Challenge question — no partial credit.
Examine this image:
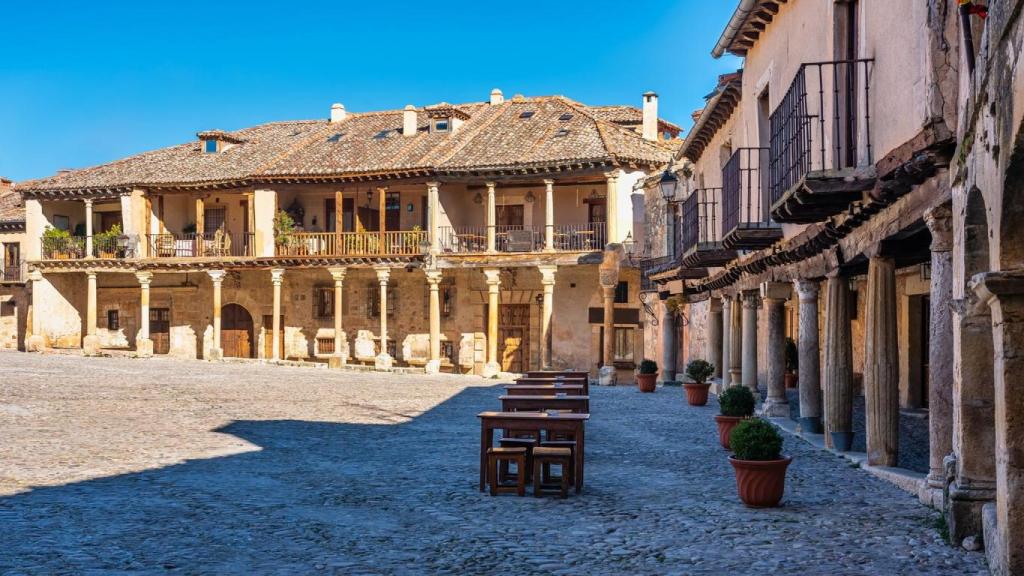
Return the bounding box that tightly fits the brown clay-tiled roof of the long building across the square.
[17,96,681,192]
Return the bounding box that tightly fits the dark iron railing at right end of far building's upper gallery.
[438,222,607,254]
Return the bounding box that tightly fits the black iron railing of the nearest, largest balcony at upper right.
[769,58,874,204]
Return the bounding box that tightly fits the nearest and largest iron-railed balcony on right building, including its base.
[769,59,876,223]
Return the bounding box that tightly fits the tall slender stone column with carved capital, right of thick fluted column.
[925,205,953,490]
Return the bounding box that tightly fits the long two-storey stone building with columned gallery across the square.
[16,90,681,379]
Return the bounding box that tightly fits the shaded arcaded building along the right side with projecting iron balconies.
[647,0,1024,574]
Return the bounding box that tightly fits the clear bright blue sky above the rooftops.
[0,0,739,180]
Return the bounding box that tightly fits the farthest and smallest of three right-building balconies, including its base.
[681,188,736,269]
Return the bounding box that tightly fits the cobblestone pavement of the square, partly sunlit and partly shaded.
[0,353,985,575]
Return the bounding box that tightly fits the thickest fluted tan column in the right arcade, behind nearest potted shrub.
[864,255,899,466]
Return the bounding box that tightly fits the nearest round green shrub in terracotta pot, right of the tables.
[729,418,793,508]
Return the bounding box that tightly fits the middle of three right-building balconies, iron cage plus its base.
[722,148,782,250]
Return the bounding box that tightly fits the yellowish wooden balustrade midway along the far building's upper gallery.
[274,231,428,256]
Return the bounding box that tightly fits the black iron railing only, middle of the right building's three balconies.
[722,148,771,238]
